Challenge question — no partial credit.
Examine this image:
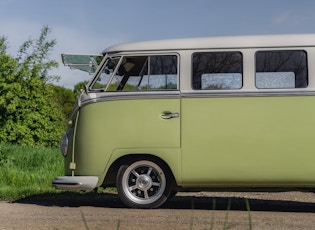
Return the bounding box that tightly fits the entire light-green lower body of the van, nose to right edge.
[65,96,315,187]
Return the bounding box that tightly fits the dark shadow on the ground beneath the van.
[14,192,315,213]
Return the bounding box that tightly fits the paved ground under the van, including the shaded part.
[0,192,315,230]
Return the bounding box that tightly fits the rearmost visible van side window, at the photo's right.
[256,50,308,89]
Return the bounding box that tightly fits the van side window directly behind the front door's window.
[192,52,243,90]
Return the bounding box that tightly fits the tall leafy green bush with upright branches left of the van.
[0,26,64,146]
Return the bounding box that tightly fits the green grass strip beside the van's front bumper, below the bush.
[0,144,64,200]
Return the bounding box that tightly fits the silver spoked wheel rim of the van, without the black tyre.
[122,161,166,204]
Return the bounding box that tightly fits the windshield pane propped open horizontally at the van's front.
[61,54,104,74]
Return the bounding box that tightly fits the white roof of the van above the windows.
[103,34,315,53]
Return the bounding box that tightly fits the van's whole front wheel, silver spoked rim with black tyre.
[117,160,170,208]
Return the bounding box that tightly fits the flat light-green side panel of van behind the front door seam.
[181,96,315,187]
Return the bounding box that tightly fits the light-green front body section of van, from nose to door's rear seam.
[74,99,180,183]
